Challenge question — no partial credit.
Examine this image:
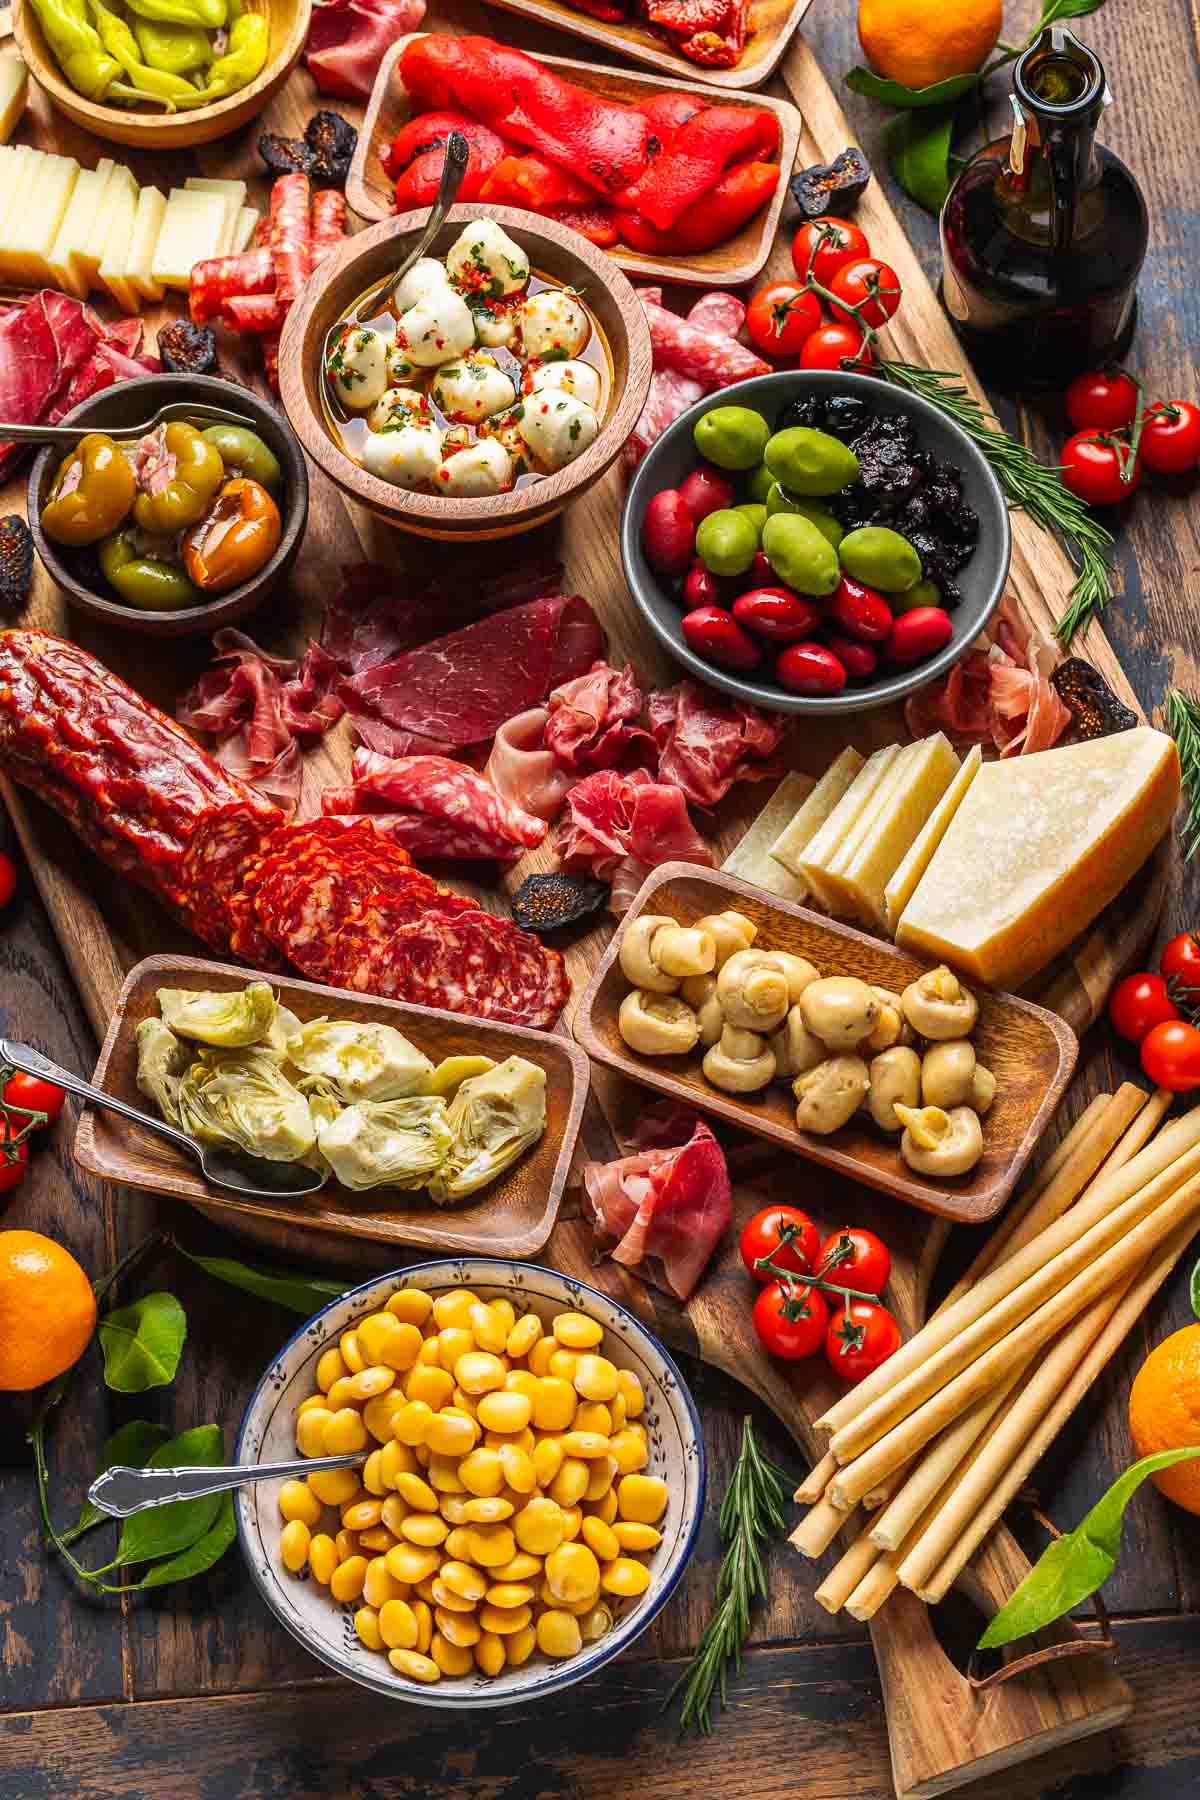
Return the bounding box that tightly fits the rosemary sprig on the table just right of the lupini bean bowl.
[662,1418,788,1732]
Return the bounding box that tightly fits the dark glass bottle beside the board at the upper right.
[941,25,1148,387]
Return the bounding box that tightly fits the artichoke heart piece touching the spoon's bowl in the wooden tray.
[178,1051,317,1163]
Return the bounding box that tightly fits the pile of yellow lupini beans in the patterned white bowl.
[279,1287,667,1681]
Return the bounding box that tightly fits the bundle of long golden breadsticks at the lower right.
[792,1082,1200,1620]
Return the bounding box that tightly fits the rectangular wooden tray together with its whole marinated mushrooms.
[574,862,1079,1224]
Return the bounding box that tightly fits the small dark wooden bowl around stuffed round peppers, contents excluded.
[25,374,308,637]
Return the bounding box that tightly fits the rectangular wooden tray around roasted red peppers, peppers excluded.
[345,32,801,288]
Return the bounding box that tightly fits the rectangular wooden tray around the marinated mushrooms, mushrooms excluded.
[574,862,1079,1224]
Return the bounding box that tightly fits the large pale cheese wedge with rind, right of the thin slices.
[896,725,1180,988]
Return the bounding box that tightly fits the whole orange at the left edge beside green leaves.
[0,1231,95,1391]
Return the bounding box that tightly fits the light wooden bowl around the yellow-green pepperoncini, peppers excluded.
[13,0,313,149]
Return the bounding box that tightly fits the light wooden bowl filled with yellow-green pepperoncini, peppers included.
[13,0,313,149]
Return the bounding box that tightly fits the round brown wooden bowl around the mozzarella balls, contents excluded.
[279,205,651,542]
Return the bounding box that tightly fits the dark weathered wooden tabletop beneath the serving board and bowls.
[0,0,1200,1800]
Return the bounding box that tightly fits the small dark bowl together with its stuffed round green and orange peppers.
[27,374,308,637]
